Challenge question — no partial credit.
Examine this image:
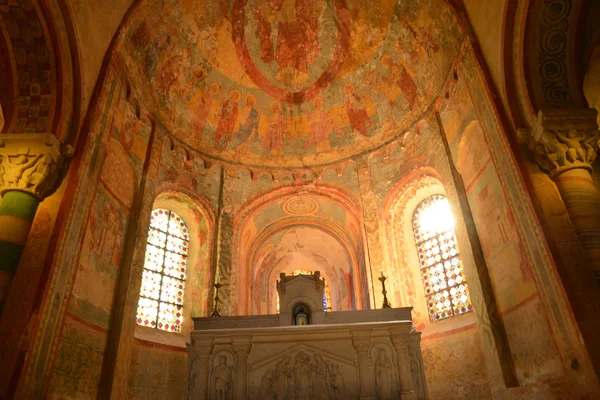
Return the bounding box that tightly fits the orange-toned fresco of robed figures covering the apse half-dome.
[119,0,459,168]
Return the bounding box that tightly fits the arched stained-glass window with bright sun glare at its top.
[412,195,473,322]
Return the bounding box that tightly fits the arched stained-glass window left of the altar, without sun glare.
[136,208,188,333]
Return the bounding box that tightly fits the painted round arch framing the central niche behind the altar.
[232,185,369,314]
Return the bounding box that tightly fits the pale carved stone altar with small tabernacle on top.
[188,275,427,400]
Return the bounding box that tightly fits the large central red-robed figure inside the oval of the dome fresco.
[255,0,324,86]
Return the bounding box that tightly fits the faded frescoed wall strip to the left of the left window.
[48,66,152,398]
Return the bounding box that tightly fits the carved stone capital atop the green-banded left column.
[0,133,73,201]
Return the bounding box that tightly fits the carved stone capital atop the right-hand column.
[528,108,600,178]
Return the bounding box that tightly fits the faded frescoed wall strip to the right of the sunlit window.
[458,56,595,398]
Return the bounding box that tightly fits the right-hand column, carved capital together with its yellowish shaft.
[529,108,600,279]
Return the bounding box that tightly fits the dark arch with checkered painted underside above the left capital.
[0,0,82,143]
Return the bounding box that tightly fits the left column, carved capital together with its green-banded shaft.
[0,133,72,314]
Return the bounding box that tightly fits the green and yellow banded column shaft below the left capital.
[0,191,40,313]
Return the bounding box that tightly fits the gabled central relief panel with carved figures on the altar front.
[248,344,359,400]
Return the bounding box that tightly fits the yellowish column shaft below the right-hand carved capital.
[554,168,600,272]
